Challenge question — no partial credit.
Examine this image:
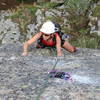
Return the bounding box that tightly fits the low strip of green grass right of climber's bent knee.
[70,35,100,49]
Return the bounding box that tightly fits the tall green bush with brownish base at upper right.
[65,0,91,33]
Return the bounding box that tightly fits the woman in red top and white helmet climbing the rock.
[23,21,76,56]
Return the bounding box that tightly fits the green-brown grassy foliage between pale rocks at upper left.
[10,5,37,33]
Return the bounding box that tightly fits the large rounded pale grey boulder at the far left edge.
[0,16,20,43]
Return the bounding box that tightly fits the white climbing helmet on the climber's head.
[40,21,56,34]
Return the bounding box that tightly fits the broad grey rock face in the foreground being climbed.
[0,44,100,100]
